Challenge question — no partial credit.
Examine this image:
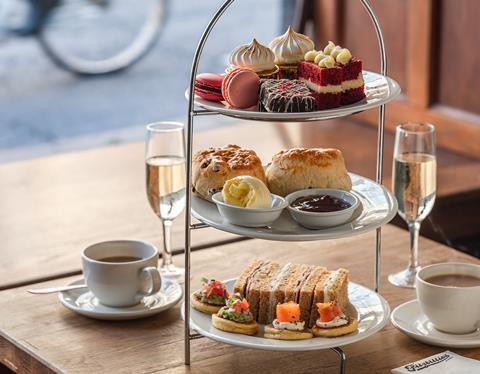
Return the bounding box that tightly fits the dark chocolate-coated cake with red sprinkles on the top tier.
[258,79,315,113]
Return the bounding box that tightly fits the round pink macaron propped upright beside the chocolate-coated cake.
[222,68,260,109]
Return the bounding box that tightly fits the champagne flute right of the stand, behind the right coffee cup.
[388,123,437,288]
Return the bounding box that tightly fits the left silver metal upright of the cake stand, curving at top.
[184,0,235,365]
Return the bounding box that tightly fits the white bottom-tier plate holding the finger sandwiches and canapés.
[181,279,390,351]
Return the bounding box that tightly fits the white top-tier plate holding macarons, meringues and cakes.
[185,70,401,122]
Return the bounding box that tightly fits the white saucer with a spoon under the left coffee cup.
[58,279,183,320]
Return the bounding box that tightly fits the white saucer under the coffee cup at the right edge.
[390,299,480,348]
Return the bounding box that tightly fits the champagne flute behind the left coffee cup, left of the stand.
[145,122,186,283]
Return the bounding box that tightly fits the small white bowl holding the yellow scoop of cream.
[212,192,288,227]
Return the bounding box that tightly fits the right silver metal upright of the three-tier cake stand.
[360,0,387,293]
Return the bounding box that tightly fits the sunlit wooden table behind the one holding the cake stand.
[0,117,480,290]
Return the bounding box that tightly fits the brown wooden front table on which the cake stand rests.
[0,225,480,374]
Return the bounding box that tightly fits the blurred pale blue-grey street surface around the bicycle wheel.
[0,0,282,162]
